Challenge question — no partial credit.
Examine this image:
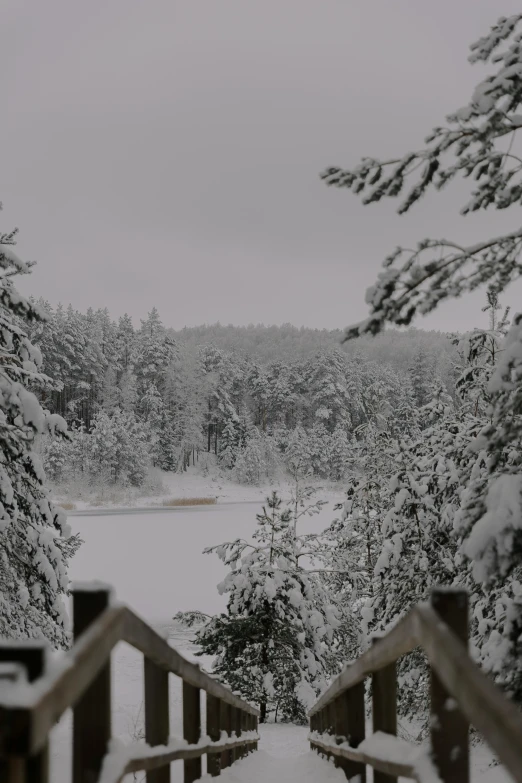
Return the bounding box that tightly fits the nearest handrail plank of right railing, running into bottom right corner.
[414,605,522,783]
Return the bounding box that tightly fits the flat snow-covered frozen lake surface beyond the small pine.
[69,502,336,623]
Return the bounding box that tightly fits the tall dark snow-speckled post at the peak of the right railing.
[430,589,469,783]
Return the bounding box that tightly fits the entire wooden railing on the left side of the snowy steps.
[0,584,259,783]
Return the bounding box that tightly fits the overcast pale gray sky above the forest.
[4,0,522,329]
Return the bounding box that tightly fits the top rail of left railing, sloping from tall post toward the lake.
[124,607,259,715]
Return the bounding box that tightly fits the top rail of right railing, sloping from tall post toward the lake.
[308,611,419,715]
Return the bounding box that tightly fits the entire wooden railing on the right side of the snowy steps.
[309,589,522,783]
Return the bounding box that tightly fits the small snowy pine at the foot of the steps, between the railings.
[197,492,339,723]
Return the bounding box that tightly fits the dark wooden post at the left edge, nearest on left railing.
[0,642,49,783]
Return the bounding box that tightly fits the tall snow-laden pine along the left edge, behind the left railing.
[0,219,80,647]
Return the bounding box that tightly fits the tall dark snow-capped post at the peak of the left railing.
[72,584,111,783]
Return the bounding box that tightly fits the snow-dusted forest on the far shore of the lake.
[30,301,456,486]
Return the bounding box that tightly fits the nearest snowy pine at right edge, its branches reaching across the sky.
[323,14,522,700]
